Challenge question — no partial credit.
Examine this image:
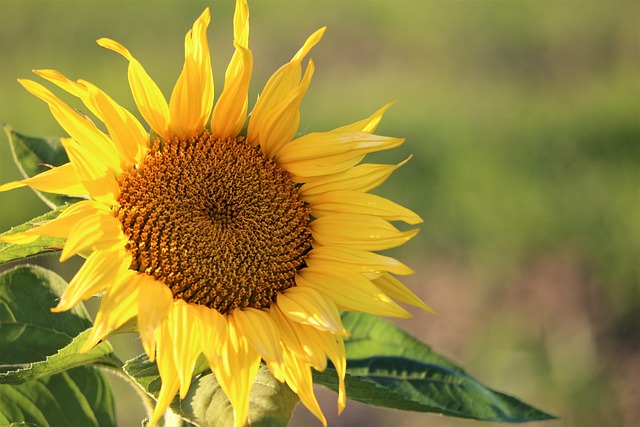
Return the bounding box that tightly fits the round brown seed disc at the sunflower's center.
[117,134,311,313]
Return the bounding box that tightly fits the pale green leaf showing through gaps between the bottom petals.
[124,354,298,427]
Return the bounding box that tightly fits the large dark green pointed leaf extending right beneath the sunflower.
[313,313,554,422]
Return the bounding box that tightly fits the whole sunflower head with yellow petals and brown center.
[0,0,429,425]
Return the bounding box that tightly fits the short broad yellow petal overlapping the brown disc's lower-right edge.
[277,286,346,334]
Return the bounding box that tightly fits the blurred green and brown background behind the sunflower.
[0,0,640,427]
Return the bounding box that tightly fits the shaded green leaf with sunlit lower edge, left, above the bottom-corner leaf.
[0,265,122,384]
